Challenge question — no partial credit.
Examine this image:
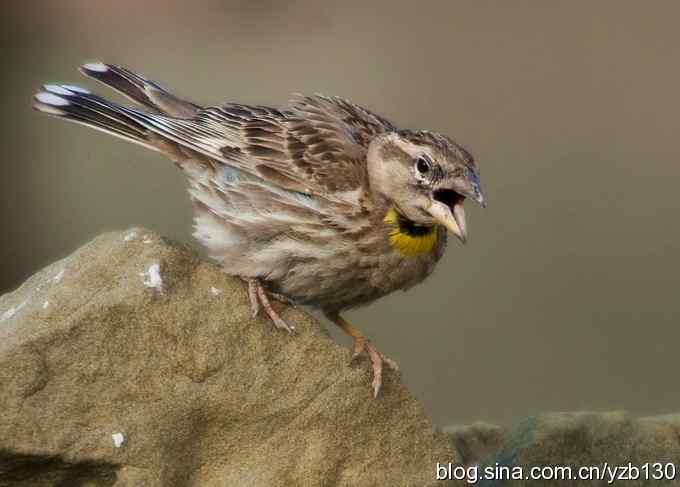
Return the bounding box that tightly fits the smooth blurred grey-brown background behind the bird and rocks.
[0,0,680,425]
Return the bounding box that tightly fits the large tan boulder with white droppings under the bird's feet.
[0,229,460,487]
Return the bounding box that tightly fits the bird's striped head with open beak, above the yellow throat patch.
[367,130,485,242]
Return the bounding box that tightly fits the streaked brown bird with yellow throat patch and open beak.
[33,61,485,397]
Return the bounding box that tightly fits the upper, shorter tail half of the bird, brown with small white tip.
[80,62,200,118]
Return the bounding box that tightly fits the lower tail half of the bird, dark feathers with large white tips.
[33,85,159,151]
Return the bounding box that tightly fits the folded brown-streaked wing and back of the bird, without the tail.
[124,95,394,203]
